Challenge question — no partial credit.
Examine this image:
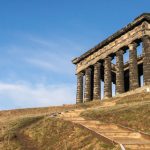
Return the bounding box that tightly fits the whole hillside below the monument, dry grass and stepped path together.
[0,93,150,150]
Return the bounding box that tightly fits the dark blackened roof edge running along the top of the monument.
[72,13,150,64]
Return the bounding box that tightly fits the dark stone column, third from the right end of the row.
[116,50,124,94]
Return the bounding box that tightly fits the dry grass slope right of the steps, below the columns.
[81,93,150,134]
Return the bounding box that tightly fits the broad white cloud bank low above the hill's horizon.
[0,82,75,109]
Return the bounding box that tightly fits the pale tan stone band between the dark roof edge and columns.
[76,22,150,73]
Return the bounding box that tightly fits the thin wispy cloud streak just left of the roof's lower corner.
[25,51,74,75]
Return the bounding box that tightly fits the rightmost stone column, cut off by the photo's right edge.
[142,35,150,85]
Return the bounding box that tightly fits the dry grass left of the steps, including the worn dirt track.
[0,116,115,150]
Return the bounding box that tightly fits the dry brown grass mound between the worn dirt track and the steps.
[22,118,115,150]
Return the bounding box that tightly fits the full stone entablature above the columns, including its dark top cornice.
[73,14,150,73]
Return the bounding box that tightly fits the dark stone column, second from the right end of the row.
[129,43,139,90]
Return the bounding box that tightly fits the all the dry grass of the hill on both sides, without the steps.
[0,93,150,150]
